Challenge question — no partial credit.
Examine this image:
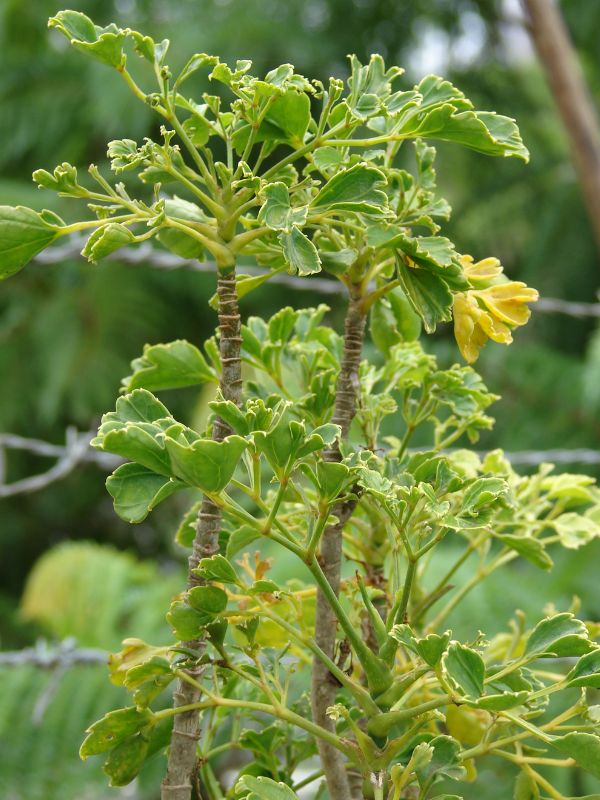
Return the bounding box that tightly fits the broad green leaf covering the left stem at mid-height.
[165,435,248,494]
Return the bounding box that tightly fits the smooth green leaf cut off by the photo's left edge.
[0,206,64,280]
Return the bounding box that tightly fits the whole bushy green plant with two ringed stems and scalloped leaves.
[0,11,600,800]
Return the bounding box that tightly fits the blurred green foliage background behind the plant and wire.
[0,0,600,800]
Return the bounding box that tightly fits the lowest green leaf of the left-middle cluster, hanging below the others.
[106,464,185,523]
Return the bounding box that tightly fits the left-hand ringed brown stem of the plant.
[161,270,242,800]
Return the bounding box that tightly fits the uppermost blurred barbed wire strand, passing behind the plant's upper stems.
[35,236,600,319]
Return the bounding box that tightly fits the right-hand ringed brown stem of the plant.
[311,294,366,800]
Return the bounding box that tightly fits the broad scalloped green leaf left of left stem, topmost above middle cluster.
[122,339,218,391]
